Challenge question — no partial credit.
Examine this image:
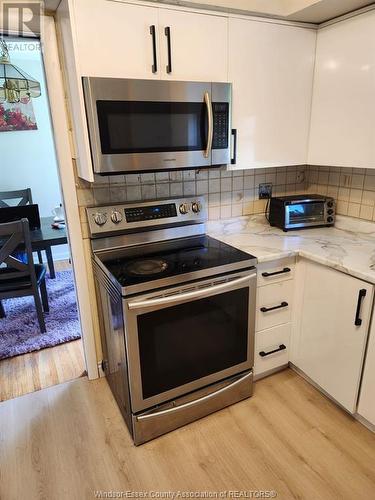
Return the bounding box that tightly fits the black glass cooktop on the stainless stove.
[102,235,256,287]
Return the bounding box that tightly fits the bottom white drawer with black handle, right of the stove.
[254,323,291,375]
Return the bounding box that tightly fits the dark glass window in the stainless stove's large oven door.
[137,288,249,399]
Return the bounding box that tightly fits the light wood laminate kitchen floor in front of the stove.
[0,369,375,500]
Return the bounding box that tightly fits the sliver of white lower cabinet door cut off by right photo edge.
[358,320,375,425]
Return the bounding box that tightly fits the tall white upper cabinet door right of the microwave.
[229,19,316,168]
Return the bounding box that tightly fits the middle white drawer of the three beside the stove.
[255,280,293,331]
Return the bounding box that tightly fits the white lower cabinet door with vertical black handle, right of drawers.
[294,262,373,413]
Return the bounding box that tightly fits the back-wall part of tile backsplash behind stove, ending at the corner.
[76,166,308,237]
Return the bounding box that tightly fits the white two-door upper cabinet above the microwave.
[74,0,228,81]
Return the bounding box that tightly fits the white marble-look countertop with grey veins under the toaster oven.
[207,215,375,284]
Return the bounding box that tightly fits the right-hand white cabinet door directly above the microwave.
[159,9,228,82]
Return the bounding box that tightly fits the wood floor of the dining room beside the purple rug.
[0,261,86,400]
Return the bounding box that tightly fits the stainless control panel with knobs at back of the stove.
[86,196,207,237]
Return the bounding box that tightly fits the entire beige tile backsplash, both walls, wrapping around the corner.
[76,165,375,238]
